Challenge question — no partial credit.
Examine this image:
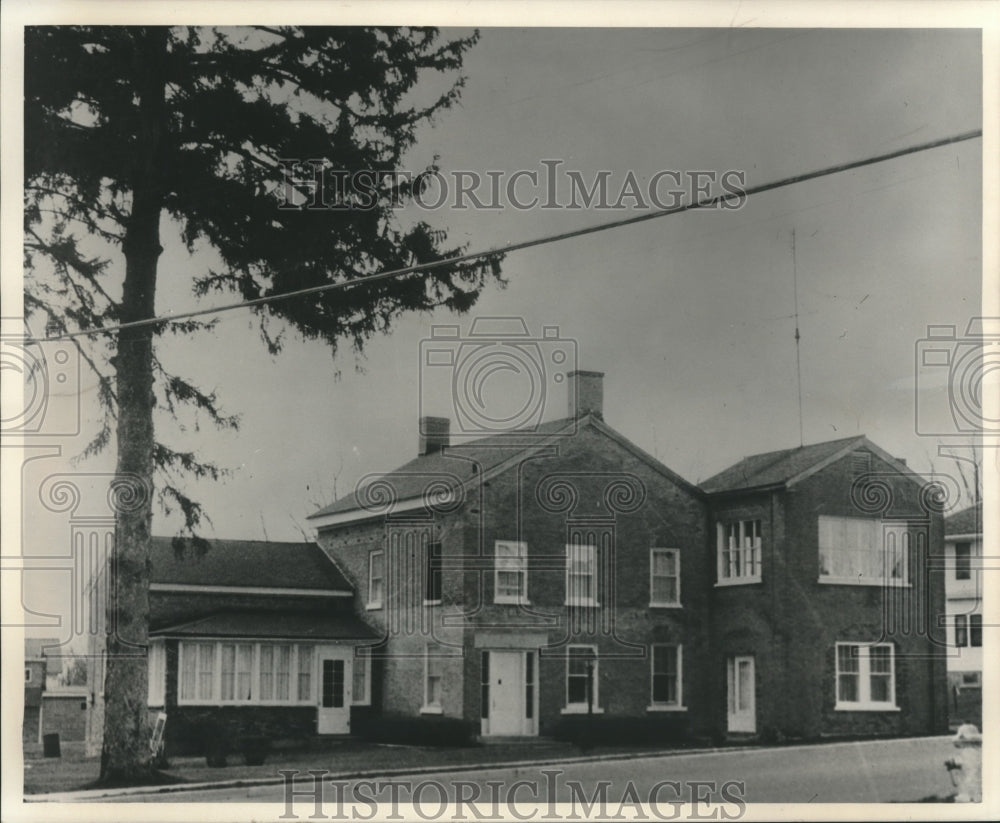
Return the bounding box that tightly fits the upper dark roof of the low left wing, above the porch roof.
[150,537,351,592]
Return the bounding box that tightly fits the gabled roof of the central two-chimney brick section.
[309,414,701,519]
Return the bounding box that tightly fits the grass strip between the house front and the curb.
[24,740,696,794]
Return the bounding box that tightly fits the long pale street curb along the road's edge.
[23,735,953,803]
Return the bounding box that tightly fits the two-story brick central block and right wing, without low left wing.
[311,372,947,738]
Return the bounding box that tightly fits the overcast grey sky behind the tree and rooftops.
[5,28,983,652]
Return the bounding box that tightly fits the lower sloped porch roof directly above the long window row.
[150,609,379,641]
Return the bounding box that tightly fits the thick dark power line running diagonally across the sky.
[31,129,983,343]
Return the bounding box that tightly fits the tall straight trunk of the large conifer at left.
[100,28,166,783]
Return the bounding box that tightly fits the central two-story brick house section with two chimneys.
[310,372,713,737]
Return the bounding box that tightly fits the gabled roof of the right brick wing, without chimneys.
[701,435,921,494]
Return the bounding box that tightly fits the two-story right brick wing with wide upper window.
[701,437,947,737]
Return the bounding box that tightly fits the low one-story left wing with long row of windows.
[88,537,374,752]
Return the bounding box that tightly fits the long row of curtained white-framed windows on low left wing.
[178,640,316,705]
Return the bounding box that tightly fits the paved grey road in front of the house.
[97,737,956,804]
